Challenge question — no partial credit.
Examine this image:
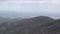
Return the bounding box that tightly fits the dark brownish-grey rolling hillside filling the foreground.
[0,16,60,34]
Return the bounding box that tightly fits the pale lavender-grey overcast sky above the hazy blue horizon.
[0,0,60,17]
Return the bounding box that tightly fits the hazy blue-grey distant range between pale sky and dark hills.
[0,11,60,19]
